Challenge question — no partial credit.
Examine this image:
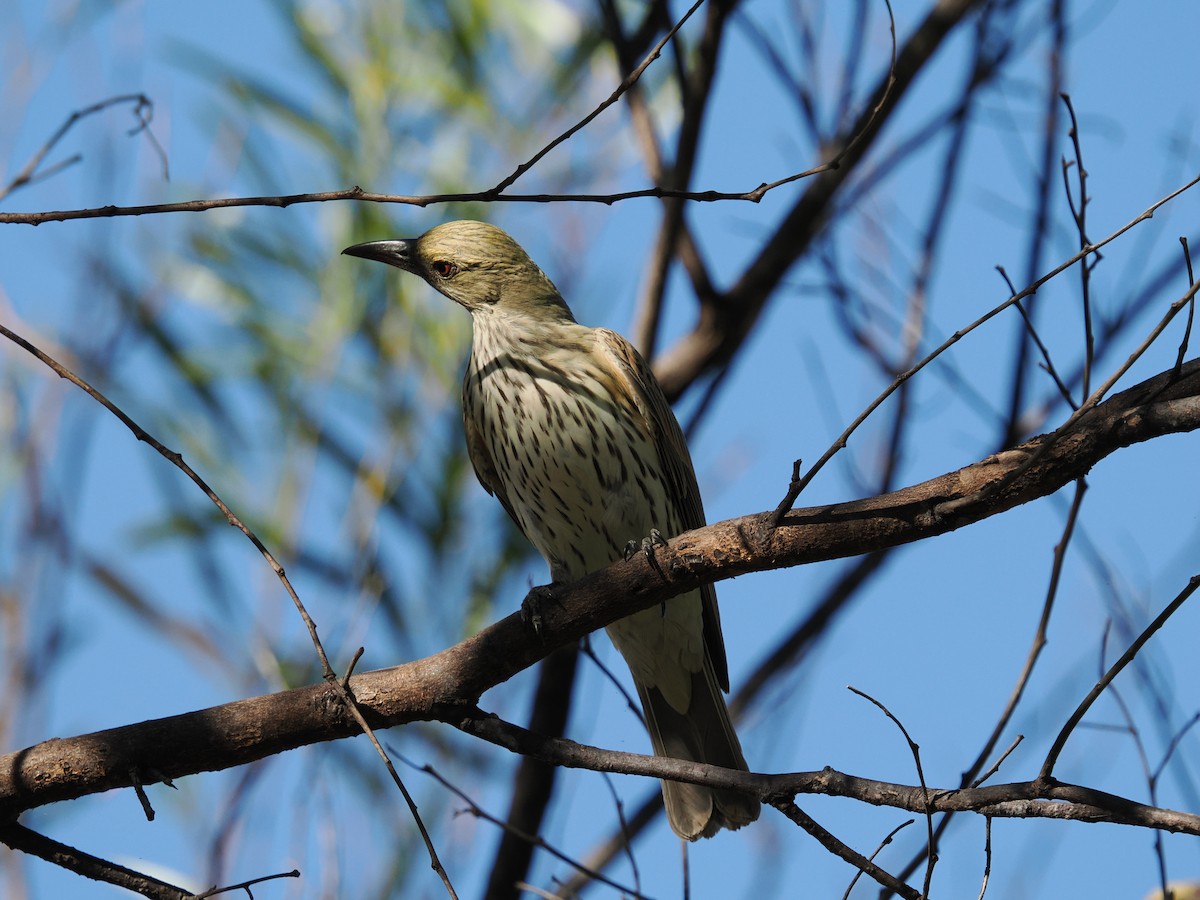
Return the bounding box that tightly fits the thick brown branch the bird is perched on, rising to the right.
[0,360,1200,820]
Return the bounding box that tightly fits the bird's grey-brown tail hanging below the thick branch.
[634,653,758,841]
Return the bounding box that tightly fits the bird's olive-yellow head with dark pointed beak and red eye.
[342,221,574,322]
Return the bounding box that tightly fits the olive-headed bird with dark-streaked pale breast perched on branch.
[342,221,760,840]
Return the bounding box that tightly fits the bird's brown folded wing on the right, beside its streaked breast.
[595,328,730,691]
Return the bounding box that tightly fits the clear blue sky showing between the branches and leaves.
[0,2,1200,898]
